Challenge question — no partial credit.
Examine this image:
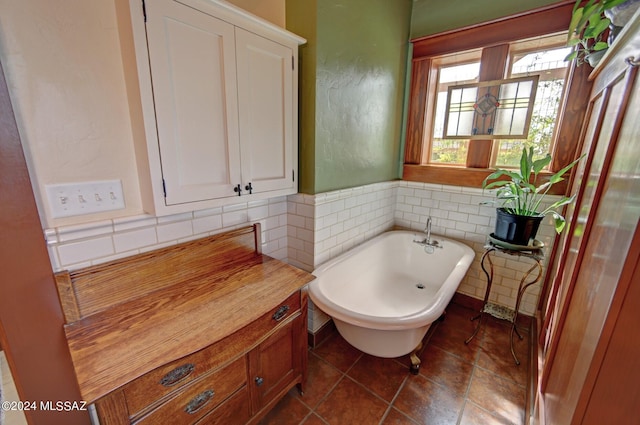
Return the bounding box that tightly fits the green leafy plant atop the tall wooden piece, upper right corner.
[565,0,628,66]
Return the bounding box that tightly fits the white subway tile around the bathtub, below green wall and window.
[288,181,555,332]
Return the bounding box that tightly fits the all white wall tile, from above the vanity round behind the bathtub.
[45,181,554,331]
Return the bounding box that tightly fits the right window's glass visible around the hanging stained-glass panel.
[495,48,570,168]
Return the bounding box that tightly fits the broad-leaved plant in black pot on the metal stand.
[482,147,584,246]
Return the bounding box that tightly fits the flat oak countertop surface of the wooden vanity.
[56,224,314,402]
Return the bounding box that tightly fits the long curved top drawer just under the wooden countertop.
[123,291,300,419]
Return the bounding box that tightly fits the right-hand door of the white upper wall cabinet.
[236,28,297,194]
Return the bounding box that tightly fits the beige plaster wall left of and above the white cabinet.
[0,0,284,228]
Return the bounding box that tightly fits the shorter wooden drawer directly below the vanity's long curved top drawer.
[135,357,248,425]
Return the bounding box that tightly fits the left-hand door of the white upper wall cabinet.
[146,0,241,205]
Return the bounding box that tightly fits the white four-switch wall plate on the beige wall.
[45,180,124,218]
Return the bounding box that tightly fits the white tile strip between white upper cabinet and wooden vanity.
[45,197,287,271]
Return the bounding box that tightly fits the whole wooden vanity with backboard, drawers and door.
[56,225,313,425]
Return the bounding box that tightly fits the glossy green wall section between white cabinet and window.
[286,0,411,193]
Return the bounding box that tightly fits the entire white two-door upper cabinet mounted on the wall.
[130,0,304,215]
